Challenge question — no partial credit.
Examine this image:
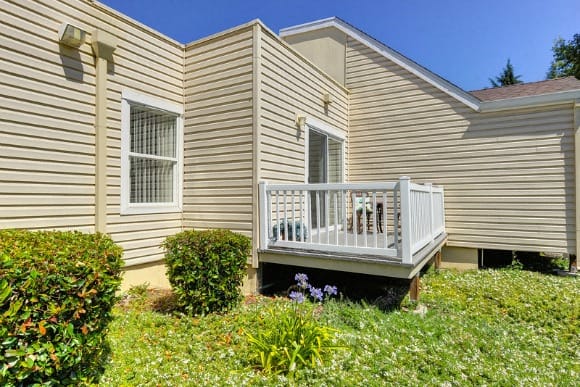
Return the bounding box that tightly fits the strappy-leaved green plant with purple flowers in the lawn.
[247,273,340,375]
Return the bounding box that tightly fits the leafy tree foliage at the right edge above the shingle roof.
[546,34,580,79]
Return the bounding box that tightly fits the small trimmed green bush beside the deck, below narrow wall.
[163,230,251,314]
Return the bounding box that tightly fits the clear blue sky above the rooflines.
[101,0,580,90]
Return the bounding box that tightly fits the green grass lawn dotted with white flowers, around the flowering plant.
[102,269,580,386]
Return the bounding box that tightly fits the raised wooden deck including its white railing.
[258,177,447,278]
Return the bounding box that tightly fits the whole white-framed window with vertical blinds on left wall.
[121,91,183,214]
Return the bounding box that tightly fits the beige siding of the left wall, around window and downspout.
[0,0,183,264]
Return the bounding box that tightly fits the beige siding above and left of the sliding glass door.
[260,30,348,183]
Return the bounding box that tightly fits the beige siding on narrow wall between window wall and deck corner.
[183,25,253,236]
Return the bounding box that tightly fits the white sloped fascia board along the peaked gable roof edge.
[280,17,481,111]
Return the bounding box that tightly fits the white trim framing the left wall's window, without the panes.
[120,89,183,215]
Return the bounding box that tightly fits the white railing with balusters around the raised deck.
[260,177,445,263]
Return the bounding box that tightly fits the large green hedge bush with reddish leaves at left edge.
[0,230,122,385]
